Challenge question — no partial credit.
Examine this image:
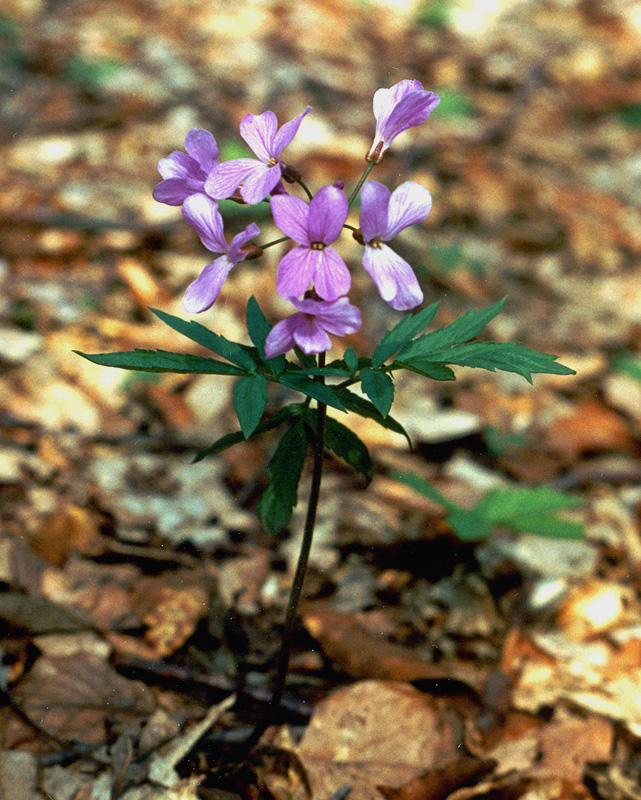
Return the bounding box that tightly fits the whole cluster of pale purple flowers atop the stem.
[153,80,439,358]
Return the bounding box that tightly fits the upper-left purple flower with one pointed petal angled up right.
[205,106,312,205]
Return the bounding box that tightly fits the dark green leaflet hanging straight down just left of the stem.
[258,419,307,534]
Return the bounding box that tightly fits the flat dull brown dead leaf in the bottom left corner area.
[14,655,155,744]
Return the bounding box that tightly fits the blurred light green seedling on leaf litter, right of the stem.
[394,472,584,542]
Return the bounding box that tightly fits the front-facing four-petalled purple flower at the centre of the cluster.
[271,186,351,300]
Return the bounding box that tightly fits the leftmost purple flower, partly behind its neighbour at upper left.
[153,128,218,206]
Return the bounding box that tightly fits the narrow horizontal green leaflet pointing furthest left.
[74,350,246,375]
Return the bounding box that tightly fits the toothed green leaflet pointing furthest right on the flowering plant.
[404,342,575,383]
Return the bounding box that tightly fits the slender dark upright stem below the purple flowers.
[236,353,327,755]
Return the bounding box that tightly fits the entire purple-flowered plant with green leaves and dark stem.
[80,80,573,747]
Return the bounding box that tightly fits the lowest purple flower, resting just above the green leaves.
[265,297,362,358]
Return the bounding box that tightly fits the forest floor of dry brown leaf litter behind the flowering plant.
[0,0,641,800]
